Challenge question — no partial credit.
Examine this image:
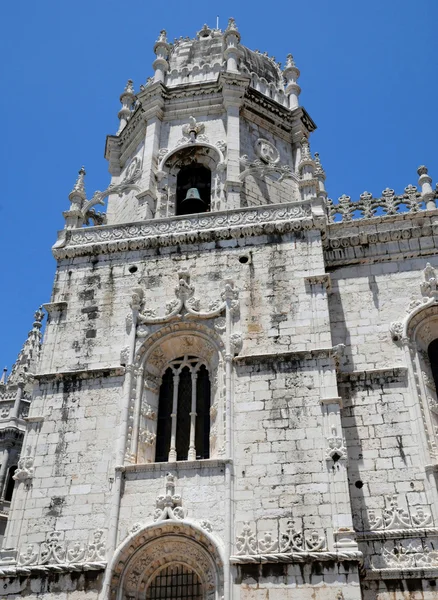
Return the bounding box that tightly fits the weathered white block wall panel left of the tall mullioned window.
[7,374,122,561]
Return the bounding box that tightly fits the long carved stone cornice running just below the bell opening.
[52,202,317,260]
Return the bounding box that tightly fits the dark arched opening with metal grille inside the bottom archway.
[146,565,203,600]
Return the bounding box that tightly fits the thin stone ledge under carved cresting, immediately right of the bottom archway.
[230,551,363,565]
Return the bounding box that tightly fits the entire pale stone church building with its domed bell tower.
[0,19,438,600]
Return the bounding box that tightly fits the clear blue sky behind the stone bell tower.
[0,0,438,367]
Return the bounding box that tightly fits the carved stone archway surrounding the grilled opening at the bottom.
[110,521,224,600]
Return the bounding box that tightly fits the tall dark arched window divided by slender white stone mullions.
[155,356,211,462]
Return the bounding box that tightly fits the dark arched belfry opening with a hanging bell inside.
[176,163,211,215]
